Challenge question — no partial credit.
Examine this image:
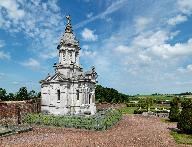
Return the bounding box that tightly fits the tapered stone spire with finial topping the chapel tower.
[57,15,80,49]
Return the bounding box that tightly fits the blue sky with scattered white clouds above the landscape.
[0,0,192,95]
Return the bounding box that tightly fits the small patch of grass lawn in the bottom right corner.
[171,131,192,145]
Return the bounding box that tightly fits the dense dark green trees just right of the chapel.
[95,85,129,103]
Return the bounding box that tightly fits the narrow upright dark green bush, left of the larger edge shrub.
[169,97,180,122]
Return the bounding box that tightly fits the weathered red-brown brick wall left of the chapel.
[0,100,41,125]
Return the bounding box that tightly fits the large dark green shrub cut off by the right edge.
[177,99,192,133]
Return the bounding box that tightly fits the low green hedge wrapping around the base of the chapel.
[23,109,122,130]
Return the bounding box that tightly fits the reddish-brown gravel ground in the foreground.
[0,115,189,147]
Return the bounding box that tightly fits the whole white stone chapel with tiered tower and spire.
[40,16,97,115]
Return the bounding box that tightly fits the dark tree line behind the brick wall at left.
[0,87,41,101]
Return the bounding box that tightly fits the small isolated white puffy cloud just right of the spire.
[81,28,98,41]
